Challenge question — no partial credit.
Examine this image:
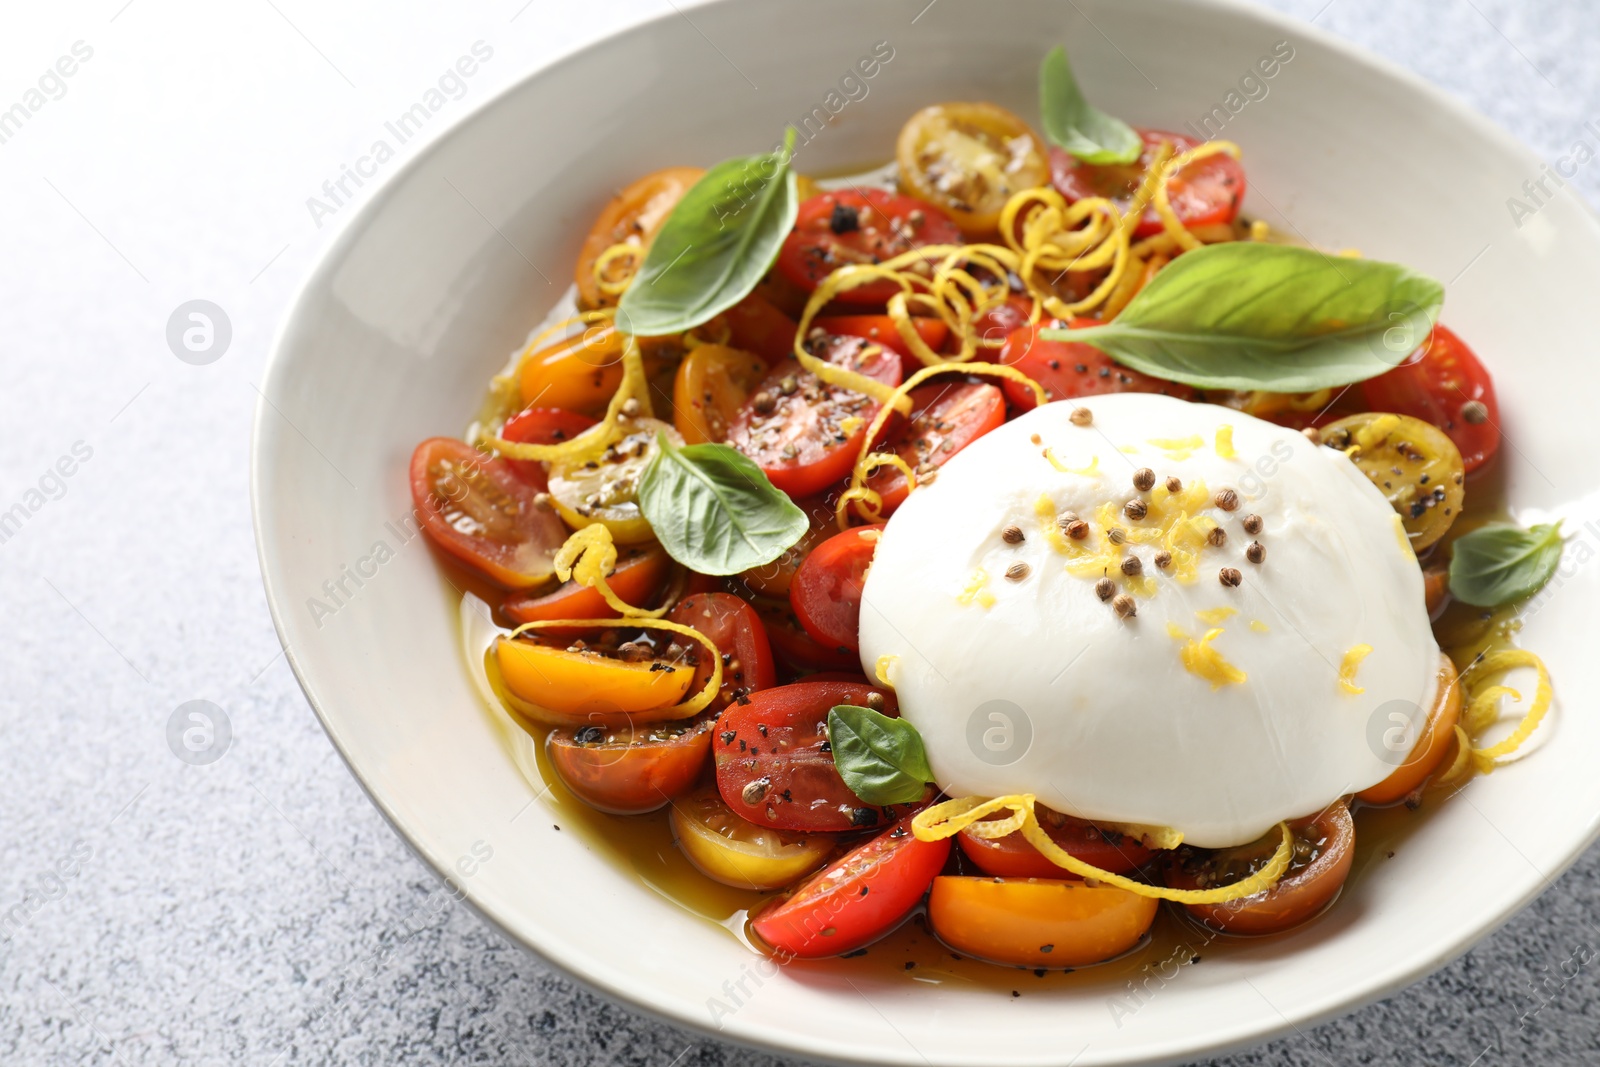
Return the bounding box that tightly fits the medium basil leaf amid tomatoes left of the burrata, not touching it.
[638,435,810,574]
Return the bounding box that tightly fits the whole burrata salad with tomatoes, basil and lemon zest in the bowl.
[410,48,1562,973]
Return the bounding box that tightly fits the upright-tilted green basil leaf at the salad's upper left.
[616,126,800,338]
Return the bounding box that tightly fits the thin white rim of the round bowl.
[250,0,1600,1065]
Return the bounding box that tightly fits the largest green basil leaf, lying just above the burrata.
[1042,242,1445,392]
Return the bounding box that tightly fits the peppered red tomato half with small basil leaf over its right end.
[710,681,907,830]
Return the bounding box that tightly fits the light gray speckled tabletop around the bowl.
[0,0,1600,1067]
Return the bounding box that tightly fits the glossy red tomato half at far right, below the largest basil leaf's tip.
[1362,326,1499,474]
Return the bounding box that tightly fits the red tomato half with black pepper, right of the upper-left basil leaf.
[778,189,962,304]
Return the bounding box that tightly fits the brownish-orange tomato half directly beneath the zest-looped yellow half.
[544,715,715,814]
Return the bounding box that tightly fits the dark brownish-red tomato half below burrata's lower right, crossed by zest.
[1162,801,1355,934]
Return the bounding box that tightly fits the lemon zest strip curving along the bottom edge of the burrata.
[910,793,1294,904]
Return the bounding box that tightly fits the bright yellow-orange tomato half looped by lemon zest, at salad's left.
[494,638,694,721]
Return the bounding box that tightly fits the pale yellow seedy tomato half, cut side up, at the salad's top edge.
[894,104,1050,237]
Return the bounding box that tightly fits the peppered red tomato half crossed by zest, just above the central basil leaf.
[728,338,901,499]
